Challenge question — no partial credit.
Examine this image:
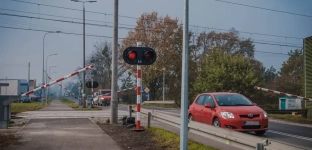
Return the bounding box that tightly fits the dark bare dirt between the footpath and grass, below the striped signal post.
[99,123,166,150]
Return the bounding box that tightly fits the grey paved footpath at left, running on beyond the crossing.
[8,100,121,150]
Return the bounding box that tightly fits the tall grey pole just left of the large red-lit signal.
[110,0,118,124]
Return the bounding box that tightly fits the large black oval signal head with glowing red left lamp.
[123,47,157,65]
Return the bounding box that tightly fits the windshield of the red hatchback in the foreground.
[215,94,253,106]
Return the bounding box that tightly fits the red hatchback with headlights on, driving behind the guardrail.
[188,92,269,135]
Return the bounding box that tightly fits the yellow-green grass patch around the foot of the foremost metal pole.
[148,127,216,150]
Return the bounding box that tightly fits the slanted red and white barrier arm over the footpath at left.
[22,65,94,96]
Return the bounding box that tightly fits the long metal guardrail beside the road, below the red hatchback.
[129,106,304,150]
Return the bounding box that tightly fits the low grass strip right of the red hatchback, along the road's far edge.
[269,114,312,124]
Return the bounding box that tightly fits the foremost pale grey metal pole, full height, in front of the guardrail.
[180,0,189,150]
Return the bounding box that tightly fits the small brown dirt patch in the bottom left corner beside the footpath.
[0,133,22,150]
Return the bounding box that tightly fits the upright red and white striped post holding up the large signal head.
[136,65,141,130]
